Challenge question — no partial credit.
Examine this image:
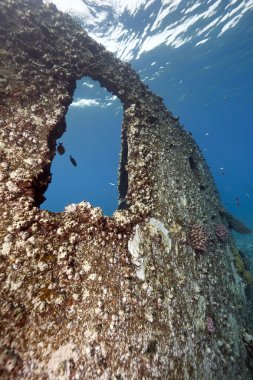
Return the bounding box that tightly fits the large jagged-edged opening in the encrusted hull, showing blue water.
[41,77,123,216]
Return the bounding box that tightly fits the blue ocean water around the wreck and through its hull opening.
[42,1,253,251]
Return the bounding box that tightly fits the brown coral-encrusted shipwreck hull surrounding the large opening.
[0,0,252,379]
